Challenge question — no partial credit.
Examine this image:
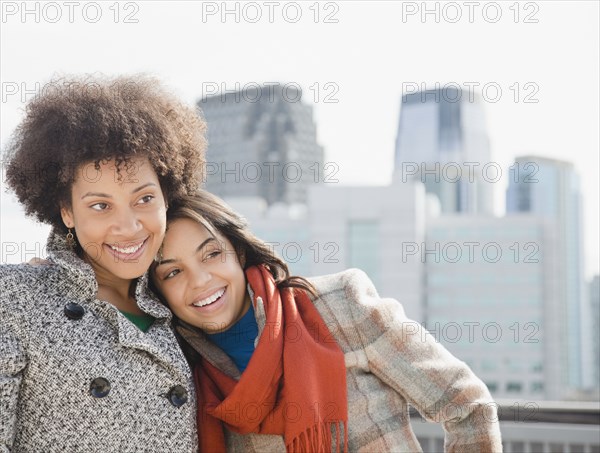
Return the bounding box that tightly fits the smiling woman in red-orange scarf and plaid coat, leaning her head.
[152,192,502,453]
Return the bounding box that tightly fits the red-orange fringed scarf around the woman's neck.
[195,265,348,452]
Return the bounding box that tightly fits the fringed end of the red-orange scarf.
[286,421,348,453]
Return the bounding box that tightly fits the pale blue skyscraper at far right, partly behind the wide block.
[506,156,584,389]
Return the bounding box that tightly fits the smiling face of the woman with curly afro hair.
[61,158,166,285]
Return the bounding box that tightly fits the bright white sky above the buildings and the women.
[0,1,600,276]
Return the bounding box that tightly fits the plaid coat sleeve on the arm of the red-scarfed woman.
[340,272,502,453]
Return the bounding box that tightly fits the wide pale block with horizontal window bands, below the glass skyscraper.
[421,214,564,400]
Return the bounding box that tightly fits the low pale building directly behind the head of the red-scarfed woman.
[226,178,427,322]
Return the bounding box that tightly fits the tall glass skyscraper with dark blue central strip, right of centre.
[394,87,492,214]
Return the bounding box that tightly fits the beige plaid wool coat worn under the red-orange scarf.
[177,269,502,453]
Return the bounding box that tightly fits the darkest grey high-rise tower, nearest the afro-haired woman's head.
[198,84,324,204]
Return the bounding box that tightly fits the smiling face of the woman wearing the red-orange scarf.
[154,218,250,333]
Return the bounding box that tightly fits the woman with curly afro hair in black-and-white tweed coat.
[0,76,206,452]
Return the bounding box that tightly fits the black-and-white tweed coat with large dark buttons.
[0,234,197,453]
